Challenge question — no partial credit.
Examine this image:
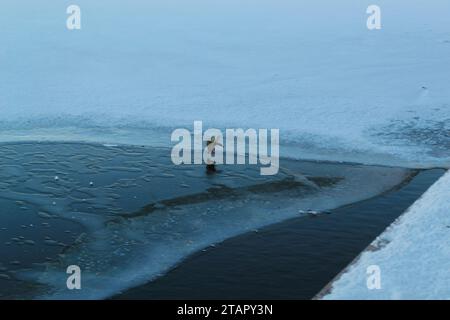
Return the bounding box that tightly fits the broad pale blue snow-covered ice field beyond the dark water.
[0,0,450,167]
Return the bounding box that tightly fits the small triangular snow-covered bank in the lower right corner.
[323,172,450,299]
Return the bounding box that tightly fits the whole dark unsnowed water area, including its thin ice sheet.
[0,143,442,299]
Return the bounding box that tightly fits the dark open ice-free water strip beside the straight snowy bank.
[115,169,444,299]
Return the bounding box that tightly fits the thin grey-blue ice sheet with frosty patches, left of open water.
[0,143,412,298]
